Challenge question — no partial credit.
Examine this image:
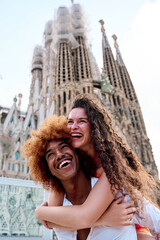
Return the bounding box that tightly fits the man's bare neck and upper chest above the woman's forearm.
[62,170,91,205]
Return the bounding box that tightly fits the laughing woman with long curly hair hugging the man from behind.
[24,95,160,239]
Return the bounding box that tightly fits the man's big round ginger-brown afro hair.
[21,115,94,191]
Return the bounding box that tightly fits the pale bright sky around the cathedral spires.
[0,0,160,176]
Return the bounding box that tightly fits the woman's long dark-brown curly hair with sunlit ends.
[71,94,157,204]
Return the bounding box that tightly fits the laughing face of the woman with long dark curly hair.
[67,107,93,152]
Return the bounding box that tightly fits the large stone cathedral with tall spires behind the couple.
[0,3,158,180]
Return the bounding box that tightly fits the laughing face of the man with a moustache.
[45,140,79,180]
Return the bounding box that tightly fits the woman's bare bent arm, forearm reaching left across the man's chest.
[36,173,114,229]
